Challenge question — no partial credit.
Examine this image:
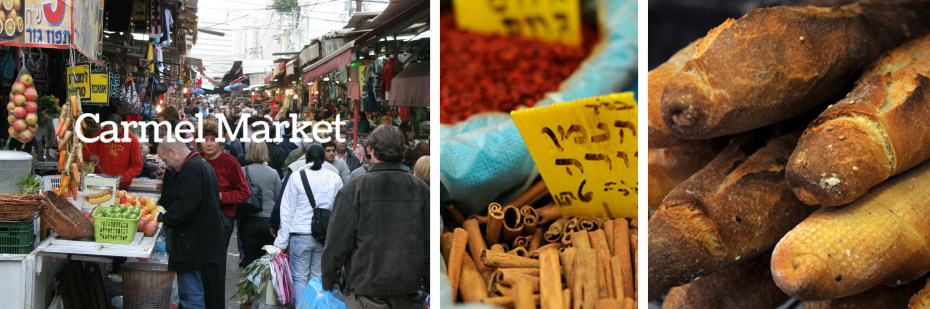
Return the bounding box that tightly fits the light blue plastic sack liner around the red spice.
[439,0,638,216]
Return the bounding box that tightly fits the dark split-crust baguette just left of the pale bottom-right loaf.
[648,130,810,295]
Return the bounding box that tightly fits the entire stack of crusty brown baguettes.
[648,0,930,308]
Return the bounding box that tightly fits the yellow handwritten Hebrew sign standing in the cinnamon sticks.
[511,92,639,218]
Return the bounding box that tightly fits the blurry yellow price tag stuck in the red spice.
[452,0,581,46]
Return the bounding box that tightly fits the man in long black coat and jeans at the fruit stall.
[158,142,226,308]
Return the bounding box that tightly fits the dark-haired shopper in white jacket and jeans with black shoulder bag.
[274,144,342,295]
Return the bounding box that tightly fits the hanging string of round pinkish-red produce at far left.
[6,74,39,144]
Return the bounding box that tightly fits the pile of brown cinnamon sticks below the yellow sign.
[440,203,638,309]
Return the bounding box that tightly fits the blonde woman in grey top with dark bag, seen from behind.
[238,143,281,267]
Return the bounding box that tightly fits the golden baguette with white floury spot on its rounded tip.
[786,36,930,206]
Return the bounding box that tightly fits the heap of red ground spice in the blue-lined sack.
[439,13,598,123]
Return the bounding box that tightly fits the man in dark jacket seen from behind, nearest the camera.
[322,126,429,308]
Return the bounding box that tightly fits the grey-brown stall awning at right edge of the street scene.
[391,61,429,107]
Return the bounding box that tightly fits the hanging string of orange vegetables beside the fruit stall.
[52,90,85,200]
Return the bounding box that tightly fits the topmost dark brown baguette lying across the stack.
[661,0,930,139]
